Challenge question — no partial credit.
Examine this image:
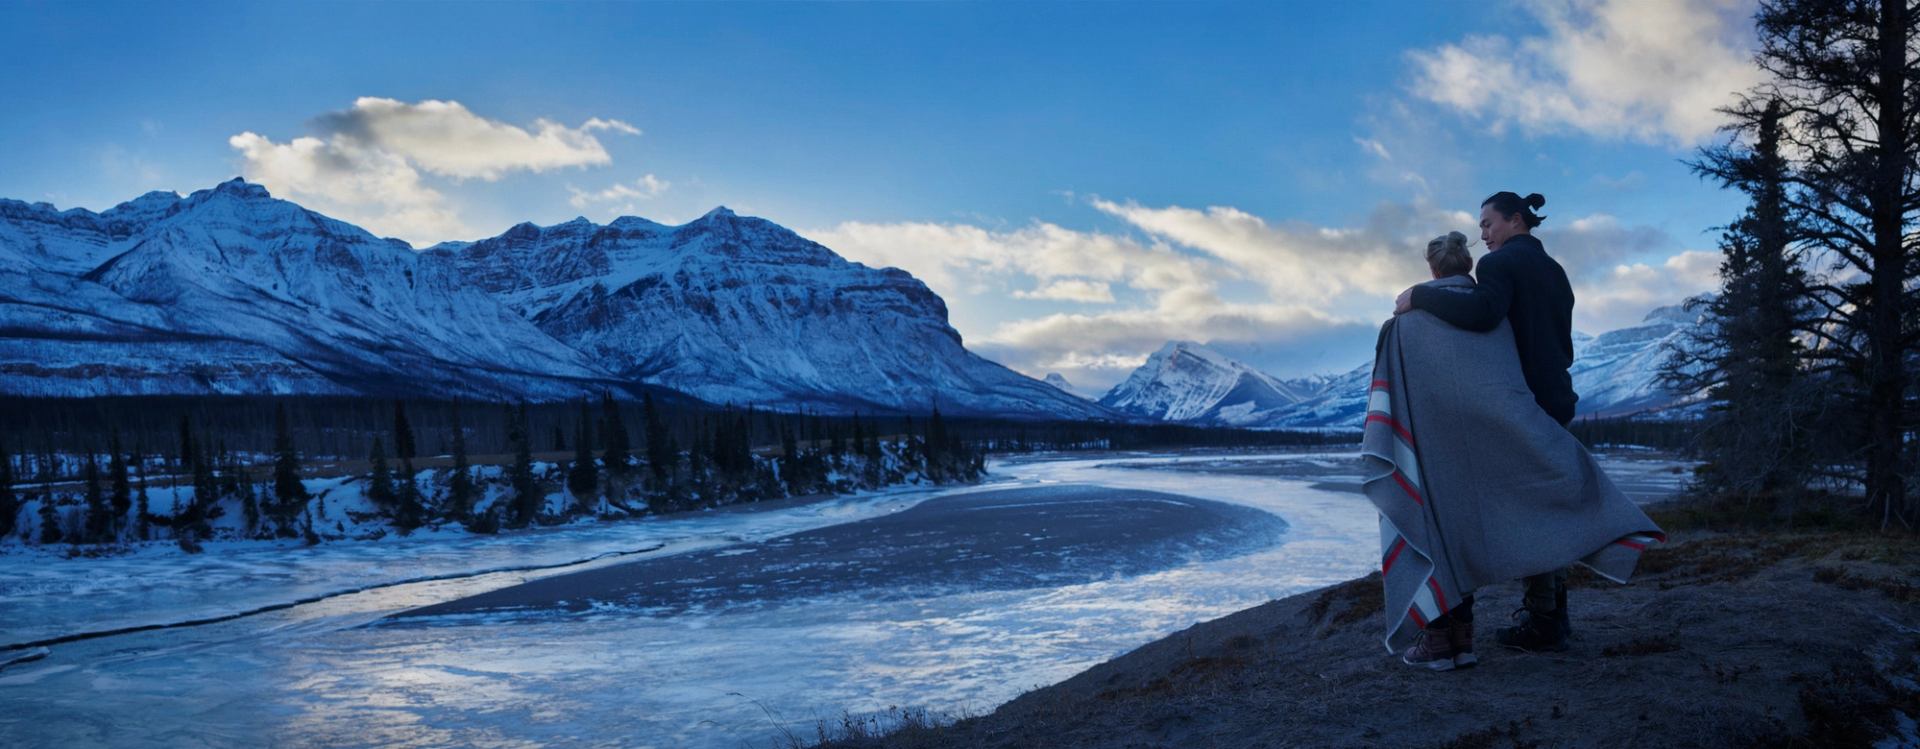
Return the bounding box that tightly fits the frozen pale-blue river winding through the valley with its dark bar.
[0,453,1682,747]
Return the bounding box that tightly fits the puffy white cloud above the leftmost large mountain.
[227,96,641,246]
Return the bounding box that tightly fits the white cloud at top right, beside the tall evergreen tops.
[1409,0,1761,146]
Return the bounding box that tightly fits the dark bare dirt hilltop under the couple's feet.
[818,519,1920,749]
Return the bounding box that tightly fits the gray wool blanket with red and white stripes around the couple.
[1361,277,1667,651]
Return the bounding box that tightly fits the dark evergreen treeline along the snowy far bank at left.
[0,396,985,549]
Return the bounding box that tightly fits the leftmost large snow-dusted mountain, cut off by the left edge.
[0,179,618,398]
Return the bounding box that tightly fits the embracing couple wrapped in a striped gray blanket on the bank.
[1361,192,1665,670]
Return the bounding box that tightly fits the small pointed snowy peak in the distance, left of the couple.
[1100,340,1313,426]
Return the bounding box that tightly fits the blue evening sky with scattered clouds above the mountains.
[0,0,1757,392]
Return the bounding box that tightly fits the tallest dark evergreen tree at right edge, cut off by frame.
[1697,0,1920,528]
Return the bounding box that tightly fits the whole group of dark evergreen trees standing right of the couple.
[1663,0,1920,528]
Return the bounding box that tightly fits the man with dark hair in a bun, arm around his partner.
[1394,192,1580,651]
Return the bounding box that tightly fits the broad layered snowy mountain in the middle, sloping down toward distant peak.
[428,207,1114,419]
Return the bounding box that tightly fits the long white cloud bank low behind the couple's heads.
[808,198,1718,390]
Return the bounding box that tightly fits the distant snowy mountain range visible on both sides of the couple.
[1100,305,1699,428]
